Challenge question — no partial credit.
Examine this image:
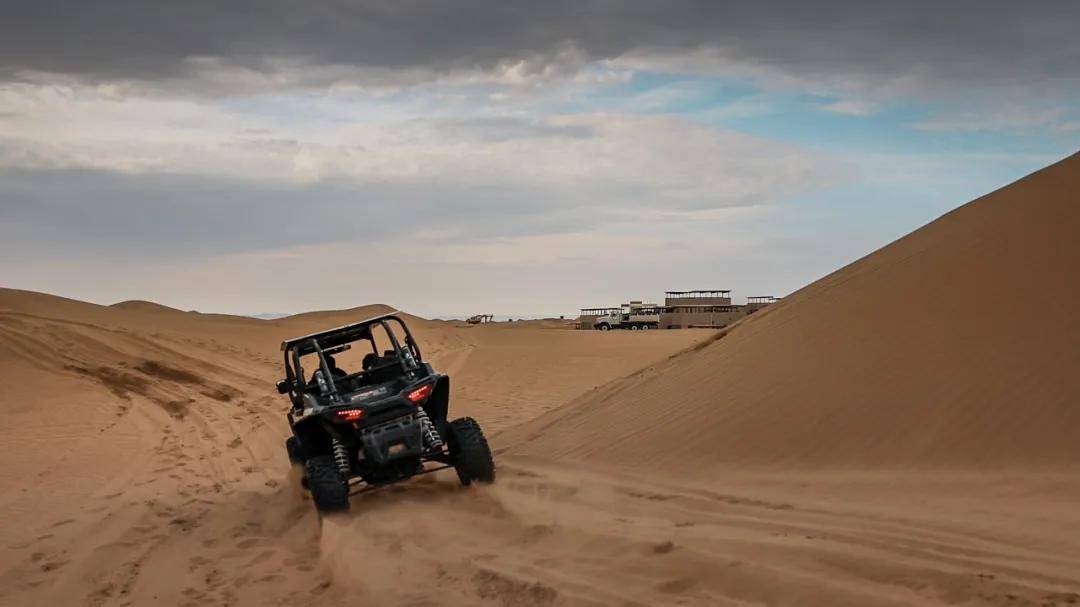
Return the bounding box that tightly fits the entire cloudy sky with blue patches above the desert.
[0,0,1080,316]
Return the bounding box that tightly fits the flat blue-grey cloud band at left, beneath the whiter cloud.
[0,165,617,259]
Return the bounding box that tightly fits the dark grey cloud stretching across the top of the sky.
[0,0,1080,93]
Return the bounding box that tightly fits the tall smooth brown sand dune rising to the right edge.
[505,150,1080,474]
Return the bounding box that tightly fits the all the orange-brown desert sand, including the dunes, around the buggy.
[0,152,1080,606]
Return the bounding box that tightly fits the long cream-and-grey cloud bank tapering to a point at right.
[0,108,838,256]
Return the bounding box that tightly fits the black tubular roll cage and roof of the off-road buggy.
[281,312,423,400]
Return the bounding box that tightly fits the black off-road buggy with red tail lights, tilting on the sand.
[278,313,495,512]
